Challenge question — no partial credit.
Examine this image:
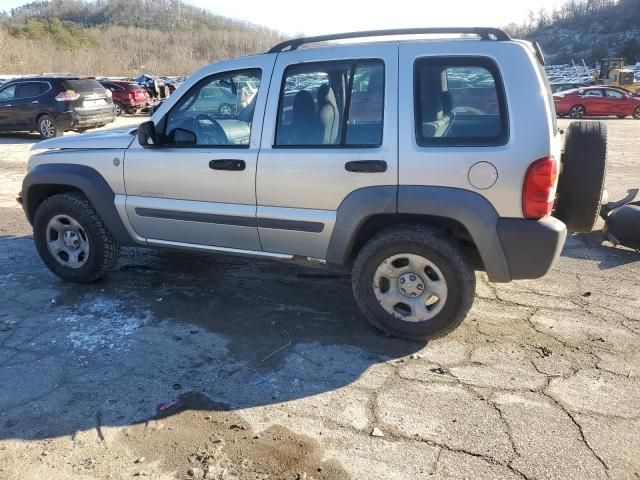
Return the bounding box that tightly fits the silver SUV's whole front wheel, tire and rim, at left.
[33,192,120,283]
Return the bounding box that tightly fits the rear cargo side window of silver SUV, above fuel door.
[414,57,509,146]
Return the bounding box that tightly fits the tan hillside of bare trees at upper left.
[0,0,282,76]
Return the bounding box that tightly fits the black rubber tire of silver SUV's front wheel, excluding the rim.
[33,192,120,283]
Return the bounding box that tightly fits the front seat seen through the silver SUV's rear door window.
[278,90,322,145]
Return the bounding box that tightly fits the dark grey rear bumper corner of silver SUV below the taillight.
[497,217,567,280]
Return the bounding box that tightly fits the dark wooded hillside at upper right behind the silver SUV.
[507,0,640,63]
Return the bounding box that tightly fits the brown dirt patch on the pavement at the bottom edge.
[122,392,348,480]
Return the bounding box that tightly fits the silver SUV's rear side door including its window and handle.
[256,44,398,259]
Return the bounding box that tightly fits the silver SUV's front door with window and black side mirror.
[124,57,273,250]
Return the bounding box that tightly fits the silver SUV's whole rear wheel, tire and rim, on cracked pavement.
[352,225,475,340]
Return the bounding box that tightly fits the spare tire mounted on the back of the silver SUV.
[554,121,607,233]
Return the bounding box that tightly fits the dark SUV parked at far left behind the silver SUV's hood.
[0,75,115,139]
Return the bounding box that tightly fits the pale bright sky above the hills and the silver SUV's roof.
[0,0,564,35]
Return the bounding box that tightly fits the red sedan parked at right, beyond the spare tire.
[553,87,640,120]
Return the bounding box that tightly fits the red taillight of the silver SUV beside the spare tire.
[522,157,558,219]
